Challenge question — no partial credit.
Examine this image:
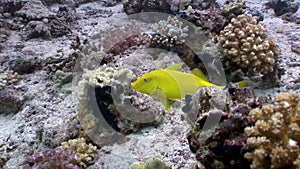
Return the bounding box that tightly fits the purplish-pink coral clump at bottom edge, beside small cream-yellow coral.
[24,148,80,169]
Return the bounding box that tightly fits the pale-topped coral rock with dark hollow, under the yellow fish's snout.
[77,65,164,146]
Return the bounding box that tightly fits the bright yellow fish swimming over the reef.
[132,63,246,109]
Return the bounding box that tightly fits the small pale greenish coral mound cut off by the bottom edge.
[130,157,171,169]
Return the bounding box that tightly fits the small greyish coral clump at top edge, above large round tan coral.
[222,0,246,21]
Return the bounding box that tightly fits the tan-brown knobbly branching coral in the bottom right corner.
[245,93,300,169]
